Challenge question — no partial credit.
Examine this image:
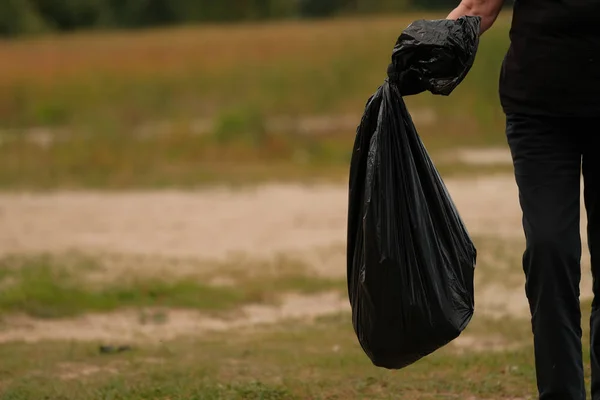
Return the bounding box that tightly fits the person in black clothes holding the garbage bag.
[447,0,600,400]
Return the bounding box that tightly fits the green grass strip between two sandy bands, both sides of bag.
[0,237,524,318]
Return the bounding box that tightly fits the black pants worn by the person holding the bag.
[506,114,600,400]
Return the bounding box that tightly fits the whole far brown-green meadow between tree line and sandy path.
[0,14,508,188]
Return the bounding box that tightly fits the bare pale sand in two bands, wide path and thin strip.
[0,170,590,346]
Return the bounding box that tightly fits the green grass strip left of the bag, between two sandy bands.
[0,257,345,318]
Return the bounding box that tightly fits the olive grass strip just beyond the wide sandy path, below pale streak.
[0,128,512,190]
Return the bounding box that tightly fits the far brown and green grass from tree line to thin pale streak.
[0,13,510,132]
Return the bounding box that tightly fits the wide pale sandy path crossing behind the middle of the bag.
[0,175,556,259]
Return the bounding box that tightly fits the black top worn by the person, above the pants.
[500,0,600,117]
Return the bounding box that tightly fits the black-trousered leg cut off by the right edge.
[583,126,600,400]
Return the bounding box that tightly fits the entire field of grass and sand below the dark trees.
[0,14,592,400]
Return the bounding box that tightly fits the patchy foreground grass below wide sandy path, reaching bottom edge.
[0,244,590,400]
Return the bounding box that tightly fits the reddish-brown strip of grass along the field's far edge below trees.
[0,15,420,84]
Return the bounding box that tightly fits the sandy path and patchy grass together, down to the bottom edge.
[0,175,591,400]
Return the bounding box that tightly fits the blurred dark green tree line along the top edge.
[0,0,458,36]
